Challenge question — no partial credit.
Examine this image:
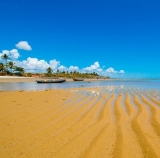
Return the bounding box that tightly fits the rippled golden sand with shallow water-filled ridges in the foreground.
[0,87,160,158]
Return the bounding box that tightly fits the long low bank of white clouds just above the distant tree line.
[13,58,125,77]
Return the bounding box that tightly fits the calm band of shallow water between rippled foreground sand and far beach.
[0,80,160,91]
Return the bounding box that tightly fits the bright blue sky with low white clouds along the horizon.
[0,0,160,77]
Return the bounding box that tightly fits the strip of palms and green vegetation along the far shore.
[0,54,109,79]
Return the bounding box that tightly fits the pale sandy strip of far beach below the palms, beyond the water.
[0,76,111,83]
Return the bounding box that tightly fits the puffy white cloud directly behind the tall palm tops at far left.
[0,49,20,60]
